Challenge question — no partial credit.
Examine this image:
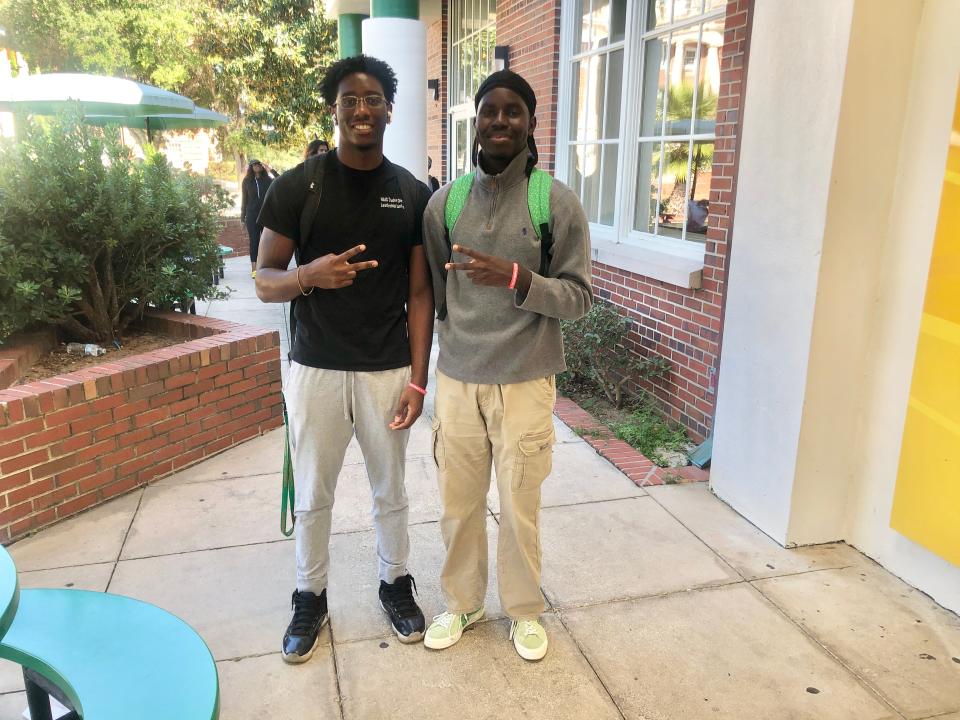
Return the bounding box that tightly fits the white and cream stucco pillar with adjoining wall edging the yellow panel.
[711,0,960,611]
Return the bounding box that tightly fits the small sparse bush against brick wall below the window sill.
[560,302,670,408]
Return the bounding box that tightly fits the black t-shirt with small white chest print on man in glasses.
[258,151,430,371]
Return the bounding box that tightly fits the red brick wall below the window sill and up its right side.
[593,0,753,440]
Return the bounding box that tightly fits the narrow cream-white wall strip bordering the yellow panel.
[848,0,960,612]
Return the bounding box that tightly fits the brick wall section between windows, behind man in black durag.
[497,0,560,172]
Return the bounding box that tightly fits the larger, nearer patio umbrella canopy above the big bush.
[0,73,195,117]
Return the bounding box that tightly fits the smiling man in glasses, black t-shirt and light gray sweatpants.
[256,55,433,663]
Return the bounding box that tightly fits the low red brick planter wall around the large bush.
[0,313,283,542]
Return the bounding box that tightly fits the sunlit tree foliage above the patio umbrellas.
[0,0,336,151]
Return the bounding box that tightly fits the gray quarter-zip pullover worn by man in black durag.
[424,151,593,384]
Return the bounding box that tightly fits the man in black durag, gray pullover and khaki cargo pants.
[424,70,593,660]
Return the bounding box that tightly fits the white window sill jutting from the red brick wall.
[590,232,703,289]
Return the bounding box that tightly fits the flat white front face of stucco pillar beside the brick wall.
[711,0,853,543]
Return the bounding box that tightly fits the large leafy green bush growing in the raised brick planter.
[0,116,227,342]
